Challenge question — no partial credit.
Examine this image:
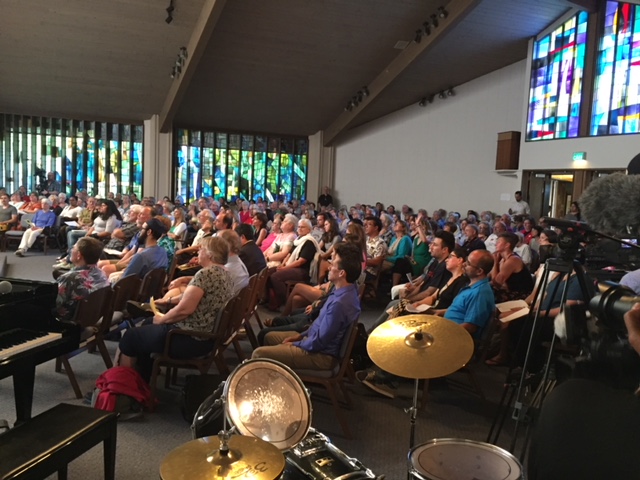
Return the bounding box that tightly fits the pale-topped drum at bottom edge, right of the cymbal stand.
[409,438,524,480]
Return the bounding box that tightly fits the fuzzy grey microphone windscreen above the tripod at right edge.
[578,173,640,237]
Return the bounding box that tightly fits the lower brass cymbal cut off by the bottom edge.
[160,435,285,480]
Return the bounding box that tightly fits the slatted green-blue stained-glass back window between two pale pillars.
[175,129,309,201]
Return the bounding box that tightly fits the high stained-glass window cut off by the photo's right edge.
[590,2,640,135]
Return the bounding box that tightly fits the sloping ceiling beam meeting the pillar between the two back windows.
[160,0,227,133]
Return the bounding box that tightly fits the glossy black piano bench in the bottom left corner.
[0,403,117,480]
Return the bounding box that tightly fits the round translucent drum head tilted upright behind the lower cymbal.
[225,359,311,450]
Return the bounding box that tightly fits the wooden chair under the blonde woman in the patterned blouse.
[149,296,240,398]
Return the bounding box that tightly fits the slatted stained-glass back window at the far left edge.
[0,114,143,197]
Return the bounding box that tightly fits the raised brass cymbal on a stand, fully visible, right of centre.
[367,315,473,379]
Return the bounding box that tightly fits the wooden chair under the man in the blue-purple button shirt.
[296,321,358,438]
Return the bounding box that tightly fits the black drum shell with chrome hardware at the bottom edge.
[280,432,383,480]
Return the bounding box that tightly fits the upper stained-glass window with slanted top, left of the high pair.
[526,12,588,140]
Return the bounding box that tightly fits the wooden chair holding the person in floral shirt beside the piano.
[55,286,113,398]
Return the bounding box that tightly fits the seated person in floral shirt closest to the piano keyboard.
[55,237,109,321]
